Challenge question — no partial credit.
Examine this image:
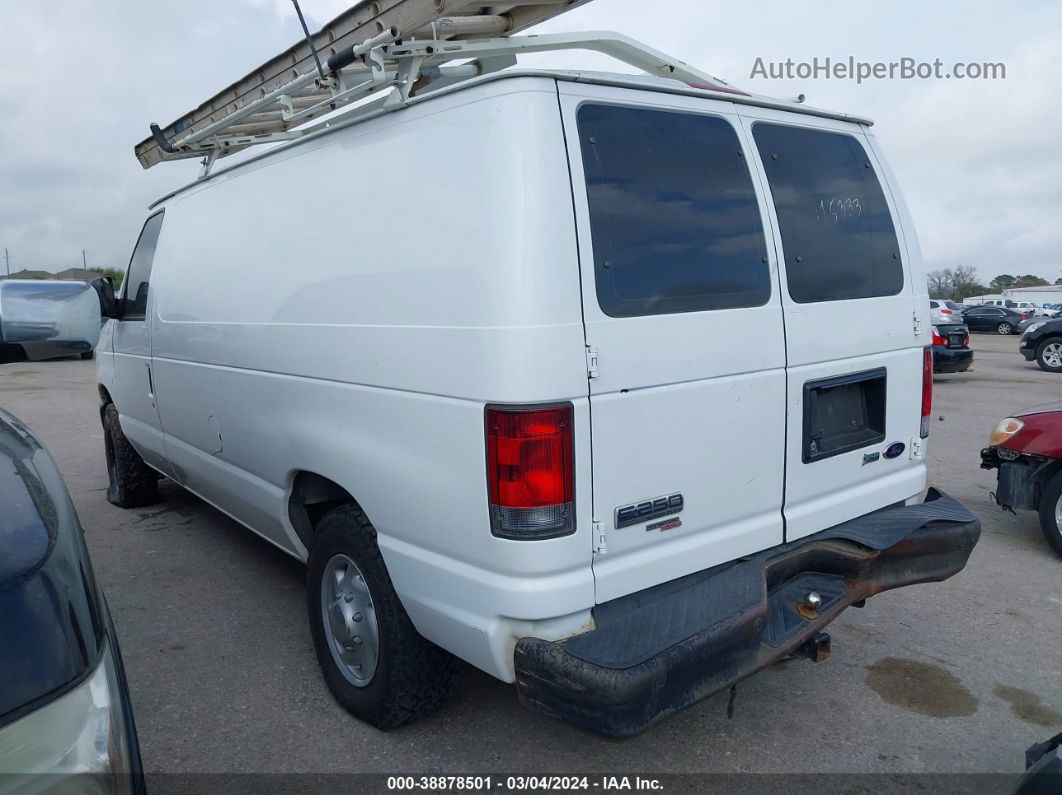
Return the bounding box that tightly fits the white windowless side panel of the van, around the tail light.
[153,77,594,679]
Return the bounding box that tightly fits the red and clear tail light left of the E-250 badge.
[485,403,576,539]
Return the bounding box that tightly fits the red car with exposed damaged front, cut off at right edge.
[981,402,1062,555]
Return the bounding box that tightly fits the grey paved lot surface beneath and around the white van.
[0,335,1062,773]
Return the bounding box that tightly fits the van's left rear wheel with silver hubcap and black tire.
[306,504,457,729]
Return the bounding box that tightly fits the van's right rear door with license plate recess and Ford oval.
[739,107,928,541]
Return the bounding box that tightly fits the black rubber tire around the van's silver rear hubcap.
[306,504,457,729]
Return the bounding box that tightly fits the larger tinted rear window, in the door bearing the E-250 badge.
[578,104,771,317]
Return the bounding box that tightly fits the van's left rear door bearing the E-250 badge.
[559,82,786,602]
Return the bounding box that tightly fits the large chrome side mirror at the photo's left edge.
[0,279,102,363]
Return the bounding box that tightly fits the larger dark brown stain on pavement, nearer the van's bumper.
[867,657,977,718]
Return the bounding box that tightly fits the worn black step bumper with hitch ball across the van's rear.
[515,488,980,737]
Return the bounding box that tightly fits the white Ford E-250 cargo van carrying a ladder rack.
[98,3,979,736]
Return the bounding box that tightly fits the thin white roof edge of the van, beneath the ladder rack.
[149,68,874,210]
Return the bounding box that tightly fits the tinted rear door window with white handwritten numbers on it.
[752,122,904,304]
